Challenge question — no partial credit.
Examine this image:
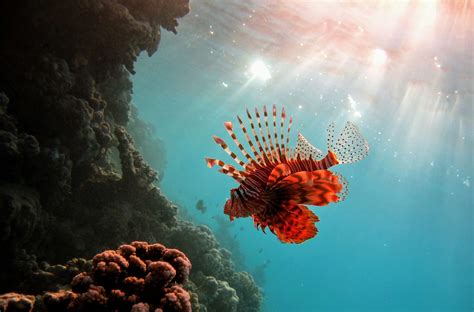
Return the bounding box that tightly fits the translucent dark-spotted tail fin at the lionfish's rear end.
[328,121,369,164]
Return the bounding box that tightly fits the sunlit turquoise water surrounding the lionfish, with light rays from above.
[133,1,474,311]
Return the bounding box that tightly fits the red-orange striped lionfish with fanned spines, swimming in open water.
[206,105,369,243]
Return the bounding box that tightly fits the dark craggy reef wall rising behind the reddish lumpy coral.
[0,0,261,311]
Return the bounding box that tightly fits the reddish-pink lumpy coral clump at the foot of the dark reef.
[43,242,191,312]
